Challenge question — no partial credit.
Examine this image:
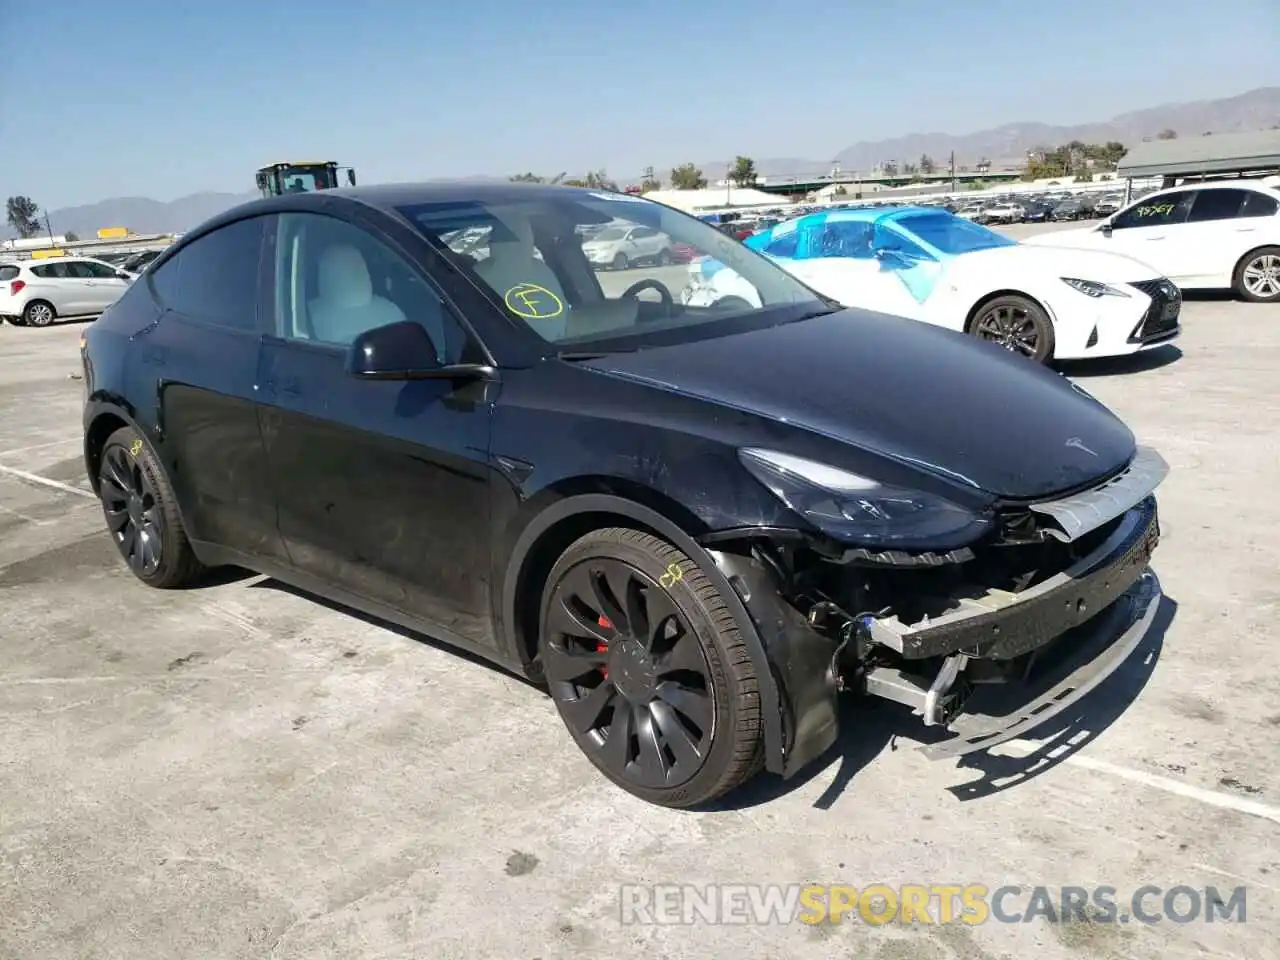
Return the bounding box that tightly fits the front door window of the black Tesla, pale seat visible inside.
[275,214,468,364]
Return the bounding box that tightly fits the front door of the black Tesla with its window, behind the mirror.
[259,207,494,646]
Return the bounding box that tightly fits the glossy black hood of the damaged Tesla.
[588,310,1135,499]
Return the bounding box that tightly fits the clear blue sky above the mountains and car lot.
[0,0,1280,209]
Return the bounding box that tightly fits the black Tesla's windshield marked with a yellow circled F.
[399,188,835,353]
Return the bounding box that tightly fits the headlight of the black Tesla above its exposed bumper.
[739,448,991,550]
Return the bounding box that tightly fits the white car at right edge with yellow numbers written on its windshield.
[1029,180,1280,303]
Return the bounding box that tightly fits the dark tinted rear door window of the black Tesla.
[151,216,266,332]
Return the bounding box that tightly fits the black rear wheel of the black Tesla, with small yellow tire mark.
[97,426,201,589]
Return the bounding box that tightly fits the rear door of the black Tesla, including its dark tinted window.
[139,216,288,562]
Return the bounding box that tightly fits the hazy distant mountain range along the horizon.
[12,87,1280,239]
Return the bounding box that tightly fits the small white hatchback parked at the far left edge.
[0,257,133,326]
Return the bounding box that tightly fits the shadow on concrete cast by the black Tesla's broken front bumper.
[699,595,1178,810]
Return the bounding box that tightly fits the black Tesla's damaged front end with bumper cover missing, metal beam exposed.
[703,448,1169,776]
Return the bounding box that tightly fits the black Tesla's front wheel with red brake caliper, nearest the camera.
[539,527,764,808]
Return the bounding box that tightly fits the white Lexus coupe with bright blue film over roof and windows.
[684,207,1181,362]
